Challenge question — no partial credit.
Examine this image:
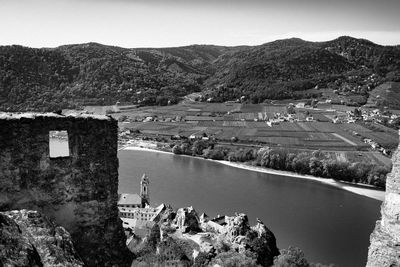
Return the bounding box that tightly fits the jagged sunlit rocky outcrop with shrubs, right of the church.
[129,207,279,266]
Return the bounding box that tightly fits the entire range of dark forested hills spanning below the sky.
[0,37,400,111]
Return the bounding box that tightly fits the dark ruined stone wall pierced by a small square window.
[0,114,130,266]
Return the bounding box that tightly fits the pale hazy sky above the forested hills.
[0,0,400,47]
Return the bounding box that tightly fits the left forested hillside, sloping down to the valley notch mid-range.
[0,43,231,110]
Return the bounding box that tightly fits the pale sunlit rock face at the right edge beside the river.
[367,135,400,267]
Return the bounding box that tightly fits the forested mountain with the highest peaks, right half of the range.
[206,36,400,103]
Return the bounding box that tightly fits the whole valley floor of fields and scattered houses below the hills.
[100,100,399,166]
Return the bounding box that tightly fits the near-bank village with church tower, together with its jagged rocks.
[118,174,277,266]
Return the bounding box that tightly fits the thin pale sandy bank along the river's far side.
[119,145,385,201]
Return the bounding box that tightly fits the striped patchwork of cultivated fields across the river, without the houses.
[94,102,398,165]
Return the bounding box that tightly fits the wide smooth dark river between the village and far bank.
[118,150,381,267]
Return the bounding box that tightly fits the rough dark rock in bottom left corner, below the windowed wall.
[0,210,83,267]
